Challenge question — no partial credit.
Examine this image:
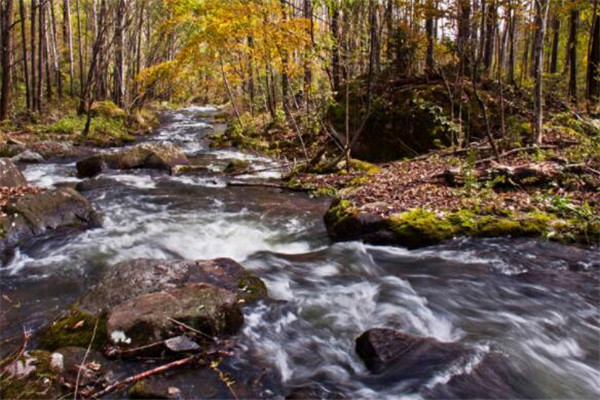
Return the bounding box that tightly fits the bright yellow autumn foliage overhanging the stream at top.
[138,0,310,99]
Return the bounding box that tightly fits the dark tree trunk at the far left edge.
[0,0,14,121]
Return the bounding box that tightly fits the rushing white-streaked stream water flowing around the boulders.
[0,107,600,398]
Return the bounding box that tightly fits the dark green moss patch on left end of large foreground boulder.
[40,308,108,351]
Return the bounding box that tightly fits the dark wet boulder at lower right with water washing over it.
[356,328,544,399]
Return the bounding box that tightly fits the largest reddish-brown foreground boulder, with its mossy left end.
[40,258,267,357]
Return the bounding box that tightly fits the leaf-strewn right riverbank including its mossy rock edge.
[213,107,600,247]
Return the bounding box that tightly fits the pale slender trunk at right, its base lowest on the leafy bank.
[533,0,550,145]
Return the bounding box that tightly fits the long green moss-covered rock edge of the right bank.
[325,200,600,248]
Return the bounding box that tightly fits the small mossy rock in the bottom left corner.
[0,350,60,400]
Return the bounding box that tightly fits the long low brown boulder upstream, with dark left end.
[77,143,189,178]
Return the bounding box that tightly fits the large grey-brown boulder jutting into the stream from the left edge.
[0,188,100,259]
